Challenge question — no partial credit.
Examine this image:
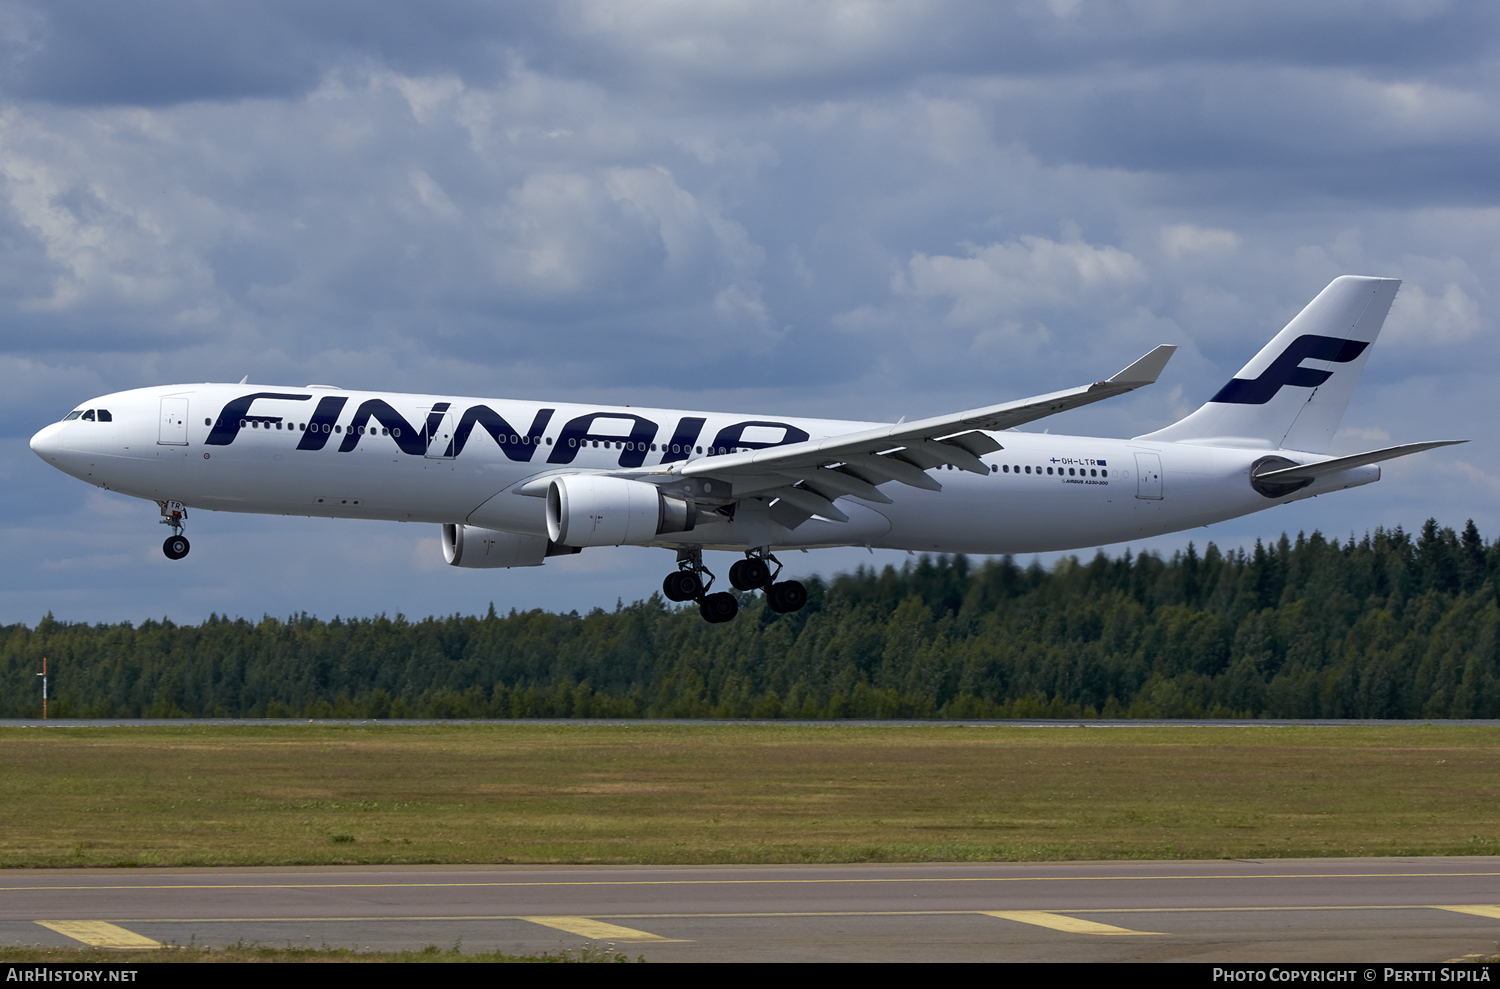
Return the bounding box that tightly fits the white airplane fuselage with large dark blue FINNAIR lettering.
[32,384,1380,554]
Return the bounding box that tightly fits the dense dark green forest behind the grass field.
[0,521,1500,719]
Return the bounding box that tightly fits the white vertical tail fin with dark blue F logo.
[1136,275,1401,453]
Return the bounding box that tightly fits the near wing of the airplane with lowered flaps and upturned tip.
[672,345,1178,528]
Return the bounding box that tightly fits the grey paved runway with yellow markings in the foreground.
[0,857,1500,962]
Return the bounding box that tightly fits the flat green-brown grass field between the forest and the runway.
[0,722,1500,867]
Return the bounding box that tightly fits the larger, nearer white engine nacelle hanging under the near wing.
[548,474,698,546]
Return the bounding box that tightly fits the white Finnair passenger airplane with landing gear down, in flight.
[32,275,1466,623]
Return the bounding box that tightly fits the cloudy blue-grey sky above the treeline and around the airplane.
[0,0,1500,624]
